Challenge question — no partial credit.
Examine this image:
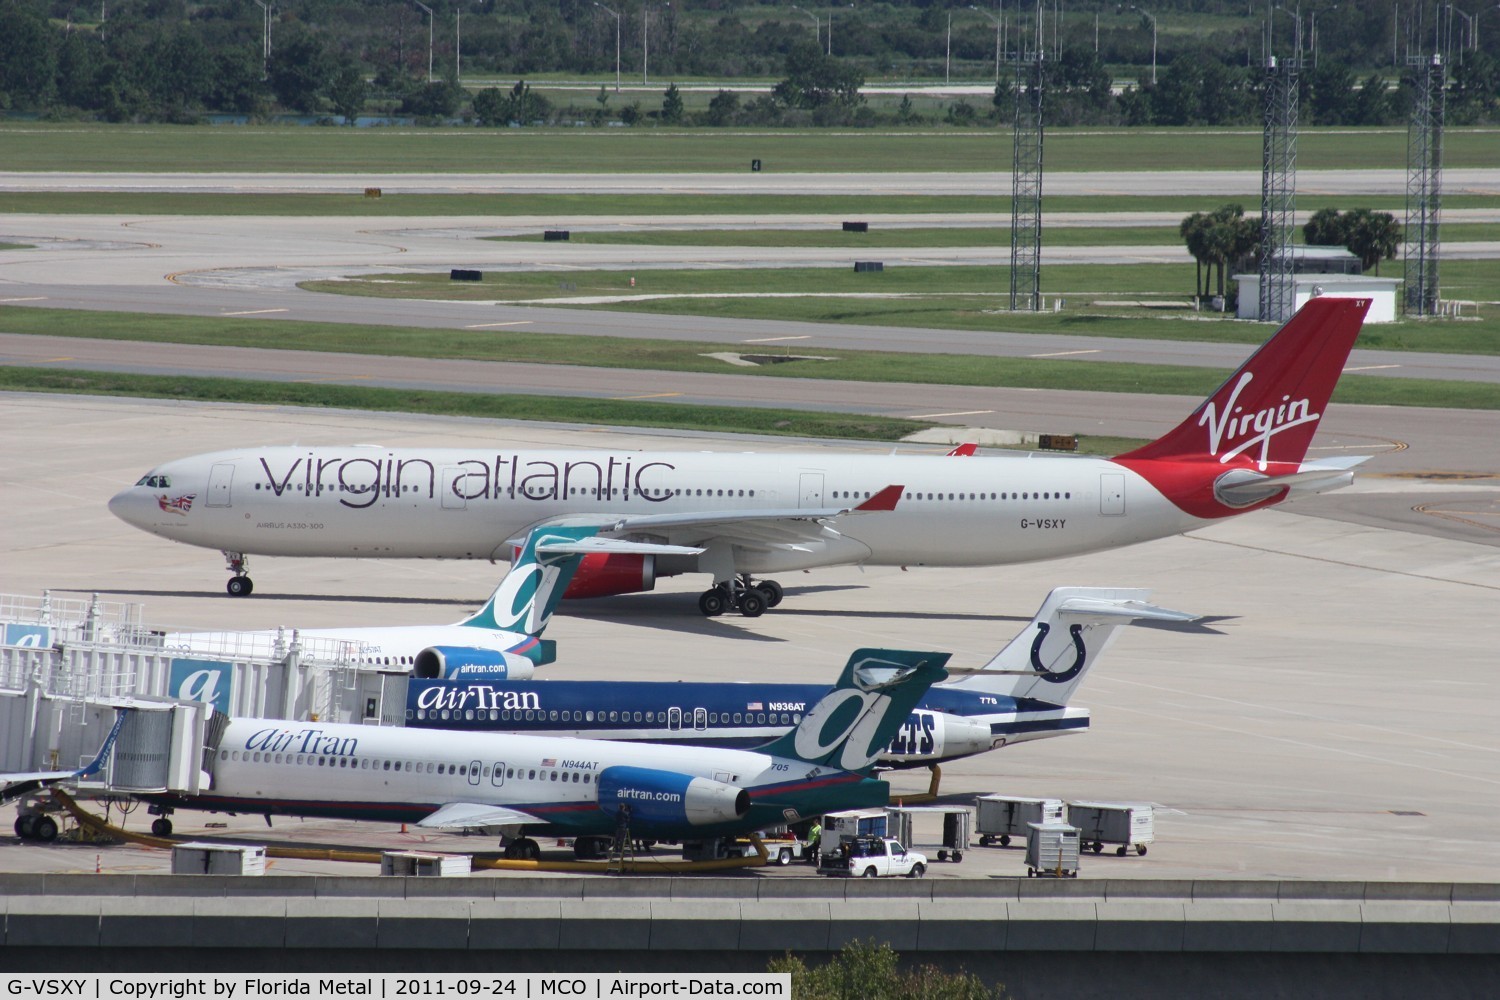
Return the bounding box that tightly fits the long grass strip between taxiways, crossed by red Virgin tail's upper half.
[0,306,1500,413]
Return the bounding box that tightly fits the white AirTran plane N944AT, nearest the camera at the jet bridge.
[26,649,948,858]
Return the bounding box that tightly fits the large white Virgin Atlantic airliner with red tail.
[110,297,1370,616]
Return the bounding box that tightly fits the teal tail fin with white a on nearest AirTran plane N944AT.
[759,649,950,772]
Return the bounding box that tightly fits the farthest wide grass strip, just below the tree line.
[0,123,1500,174]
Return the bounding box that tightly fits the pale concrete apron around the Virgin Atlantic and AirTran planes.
[0,394,1500,882]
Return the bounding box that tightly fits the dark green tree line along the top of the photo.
[0,0,1500,126]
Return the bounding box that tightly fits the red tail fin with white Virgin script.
[1116,295,1370,471]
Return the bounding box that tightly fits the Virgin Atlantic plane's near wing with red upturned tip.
[522,486,906,552]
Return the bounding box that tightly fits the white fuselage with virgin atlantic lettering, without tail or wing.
[110,447,1206,573]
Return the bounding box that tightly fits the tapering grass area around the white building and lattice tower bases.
[305,261,1500,346]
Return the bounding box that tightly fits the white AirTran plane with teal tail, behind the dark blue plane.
[162,526,698,681]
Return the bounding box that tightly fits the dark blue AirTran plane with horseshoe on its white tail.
[407,586,1197,768]
